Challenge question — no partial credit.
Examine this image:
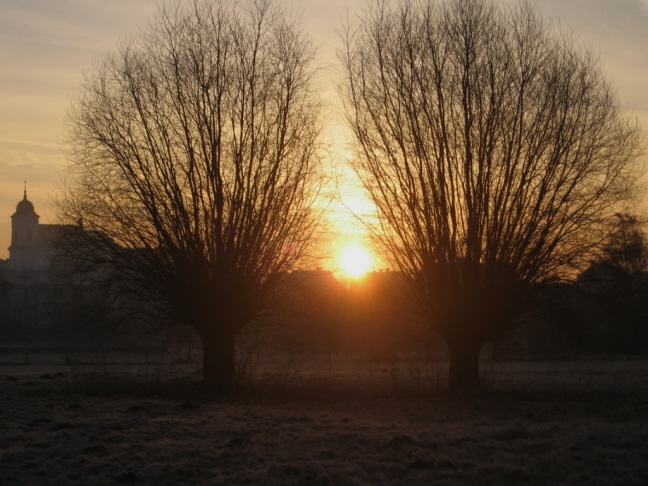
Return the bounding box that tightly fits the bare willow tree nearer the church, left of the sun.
[60,0,321,394]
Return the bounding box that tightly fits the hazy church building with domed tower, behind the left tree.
[0,190,175,349]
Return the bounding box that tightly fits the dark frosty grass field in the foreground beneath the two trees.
[0,361,648,485]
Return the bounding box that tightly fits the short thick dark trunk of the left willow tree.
[201,333,237,399]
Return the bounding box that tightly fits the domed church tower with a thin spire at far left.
[8,187,44,271]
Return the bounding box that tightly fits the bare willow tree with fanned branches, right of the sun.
[340,0,641,388]
